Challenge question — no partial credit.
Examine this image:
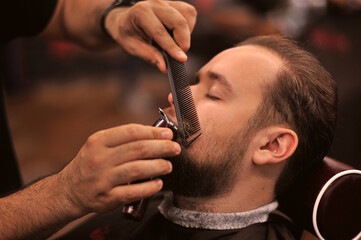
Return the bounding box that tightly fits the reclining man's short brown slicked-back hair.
[237,36,338,197]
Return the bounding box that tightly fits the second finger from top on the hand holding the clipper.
[112,140,181,165]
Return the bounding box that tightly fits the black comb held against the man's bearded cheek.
[161,49,202,146]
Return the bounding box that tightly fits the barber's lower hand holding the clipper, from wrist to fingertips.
[59,124,180,214]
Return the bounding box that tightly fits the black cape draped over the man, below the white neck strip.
[60,195,296,240]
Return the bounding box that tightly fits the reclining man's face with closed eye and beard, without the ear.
[165,45,281,197]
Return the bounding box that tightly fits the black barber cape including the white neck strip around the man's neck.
[60,193,296,240]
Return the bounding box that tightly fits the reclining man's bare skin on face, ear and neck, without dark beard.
[166,46,298,212]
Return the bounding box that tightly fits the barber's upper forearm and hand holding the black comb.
[40,0,197,72]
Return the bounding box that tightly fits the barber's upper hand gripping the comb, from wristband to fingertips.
[105,0,197,72]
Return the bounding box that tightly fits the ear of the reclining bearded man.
[252,126,298,165]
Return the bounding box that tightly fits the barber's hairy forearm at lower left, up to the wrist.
[0,174,83,239]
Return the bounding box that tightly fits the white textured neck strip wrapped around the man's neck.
[158,193,278,230]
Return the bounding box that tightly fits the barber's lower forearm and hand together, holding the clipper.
[0,124,181,239]
